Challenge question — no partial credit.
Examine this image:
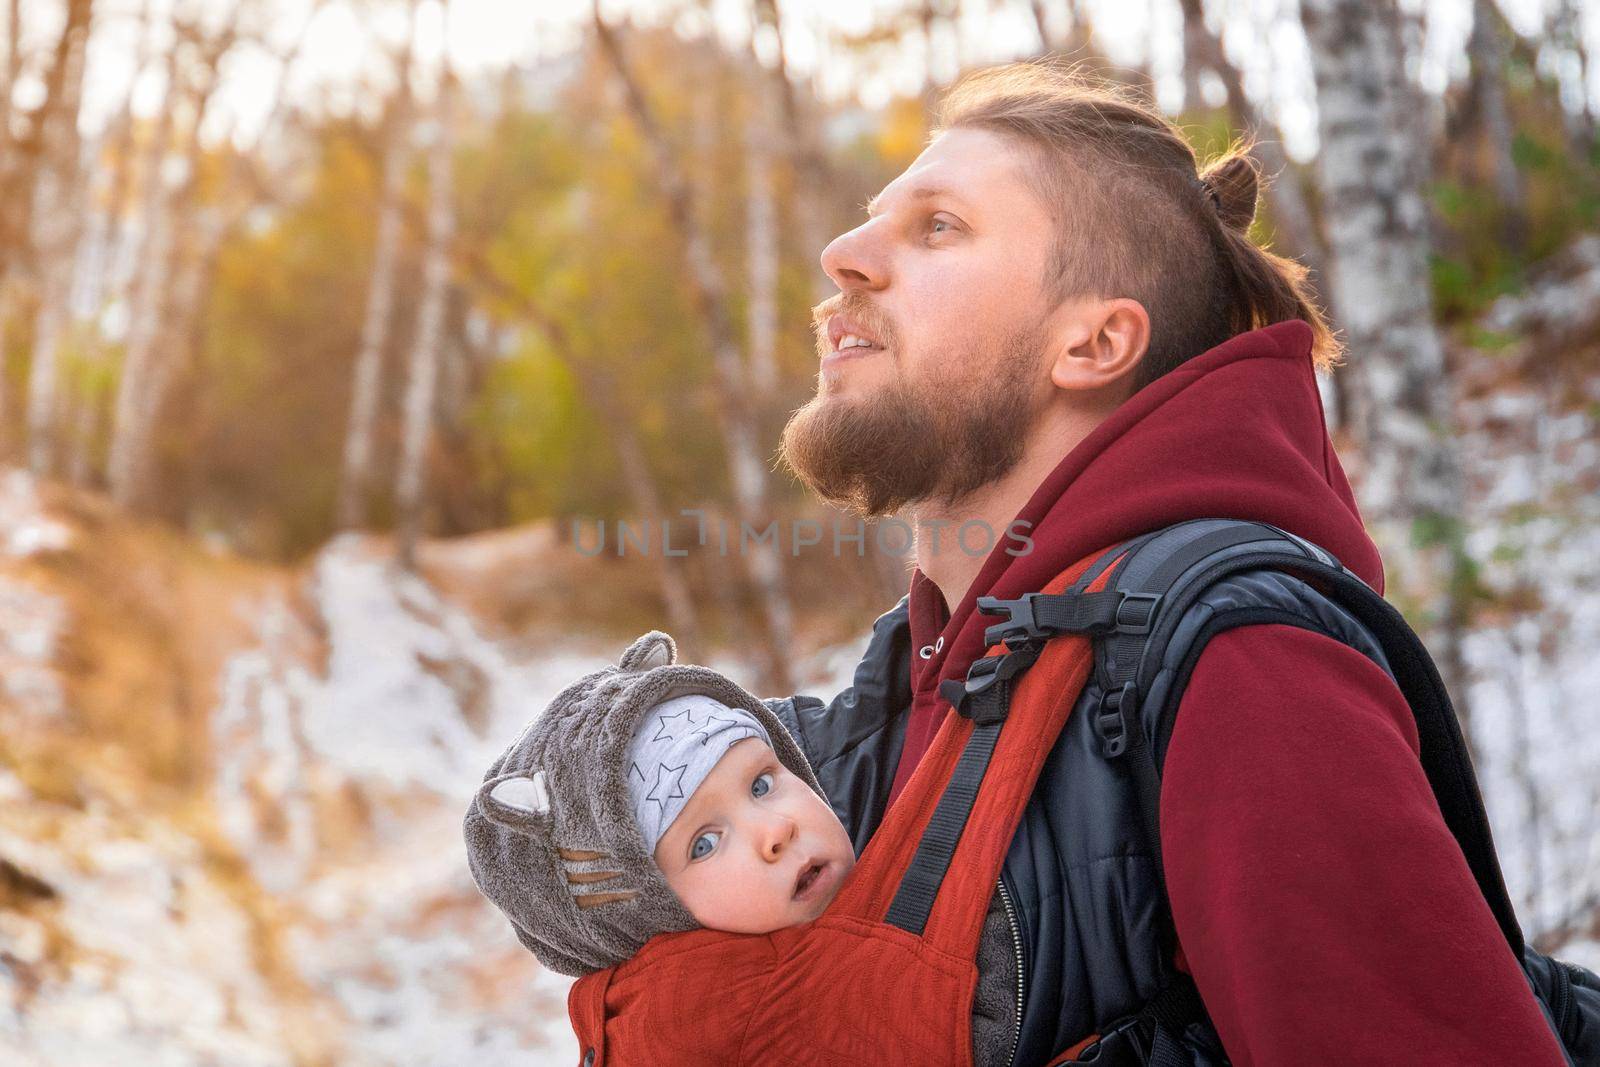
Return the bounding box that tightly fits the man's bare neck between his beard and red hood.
[907,406,1104,611]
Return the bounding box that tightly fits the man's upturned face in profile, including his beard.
[784,128,1053,515]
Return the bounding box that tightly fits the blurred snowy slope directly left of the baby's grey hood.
[201,537,883,1067]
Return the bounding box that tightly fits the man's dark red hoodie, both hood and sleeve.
[893,322,1565,1065]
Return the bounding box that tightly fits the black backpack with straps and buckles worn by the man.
[944,518,1600,1067]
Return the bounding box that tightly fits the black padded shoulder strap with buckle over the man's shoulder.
[979,518,1523,958]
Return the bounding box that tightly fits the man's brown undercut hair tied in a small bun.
[933,59,1341,389]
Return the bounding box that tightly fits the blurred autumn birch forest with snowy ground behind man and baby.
[0,0,1600,1065]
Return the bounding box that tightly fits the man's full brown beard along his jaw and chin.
[781,321,1043,517]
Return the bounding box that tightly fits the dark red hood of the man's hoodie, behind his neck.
[891,320,1382,797]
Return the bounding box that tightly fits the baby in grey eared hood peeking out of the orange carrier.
[464,632,1016,1067]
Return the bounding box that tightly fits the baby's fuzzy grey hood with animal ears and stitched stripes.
[462,630,822,976]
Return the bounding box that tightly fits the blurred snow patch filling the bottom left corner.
[0,789,291,1067]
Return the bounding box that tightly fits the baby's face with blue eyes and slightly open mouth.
[656,737,856,934]
